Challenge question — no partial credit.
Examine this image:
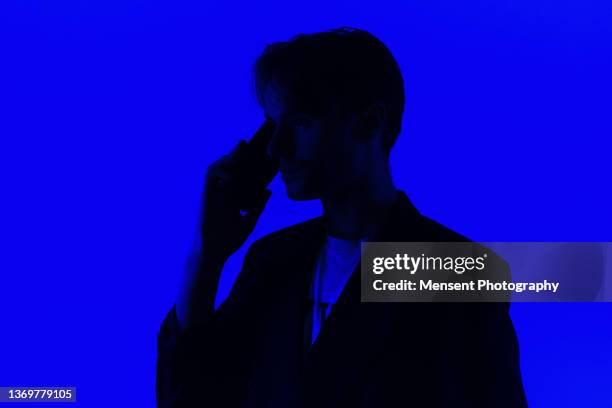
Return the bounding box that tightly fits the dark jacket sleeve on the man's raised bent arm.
[156,247,261,408]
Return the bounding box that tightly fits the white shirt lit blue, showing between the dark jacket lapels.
[310,235,365,344]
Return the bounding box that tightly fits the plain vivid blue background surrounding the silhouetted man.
[0,0,612,407]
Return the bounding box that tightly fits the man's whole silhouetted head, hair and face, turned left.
[254,28,404,200]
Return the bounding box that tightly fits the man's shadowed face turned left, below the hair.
[262,81,356,200]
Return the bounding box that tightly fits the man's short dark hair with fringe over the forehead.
[254,27,404,154]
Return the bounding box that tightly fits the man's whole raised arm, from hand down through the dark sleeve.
[157,142,270,408]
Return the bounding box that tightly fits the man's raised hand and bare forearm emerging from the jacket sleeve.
[176,141,271,330]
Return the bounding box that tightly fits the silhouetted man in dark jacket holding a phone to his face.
[157,28,526,407]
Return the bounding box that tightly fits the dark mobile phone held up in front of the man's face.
[240,120,278,212]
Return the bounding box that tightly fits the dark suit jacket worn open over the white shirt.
[156,192,527,408]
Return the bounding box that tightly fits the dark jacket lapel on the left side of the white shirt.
[248,217,325,407]
